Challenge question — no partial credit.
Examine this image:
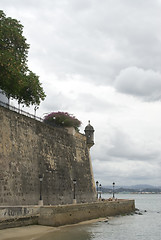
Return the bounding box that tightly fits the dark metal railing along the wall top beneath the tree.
[0,101,43,122]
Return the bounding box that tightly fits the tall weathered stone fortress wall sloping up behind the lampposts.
[0,107,96,206]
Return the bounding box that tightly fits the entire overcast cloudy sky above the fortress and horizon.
[0,0,161,186]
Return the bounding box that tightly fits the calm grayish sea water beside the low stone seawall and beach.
[36,194,161,240]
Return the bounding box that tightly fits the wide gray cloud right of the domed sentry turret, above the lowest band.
[93,127,161,163]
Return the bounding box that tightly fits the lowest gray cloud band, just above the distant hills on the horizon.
[93,160,161,186]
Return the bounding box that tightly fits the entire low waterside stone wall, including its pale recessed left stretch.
[0,200,135,229]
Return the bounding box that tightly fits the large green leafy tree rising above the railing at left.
[0,10,45,106]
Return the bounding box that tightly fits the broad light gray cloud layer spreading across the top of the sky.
[1,0,161,84]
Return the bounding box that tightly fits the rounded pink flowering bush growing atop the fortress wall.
[44,112,81,131]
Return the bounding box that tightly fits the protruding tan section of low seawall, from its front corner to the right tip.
[38,200,135,227]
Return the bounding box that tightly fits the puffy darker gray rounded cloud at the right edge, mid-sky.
[115,67,161,101]
